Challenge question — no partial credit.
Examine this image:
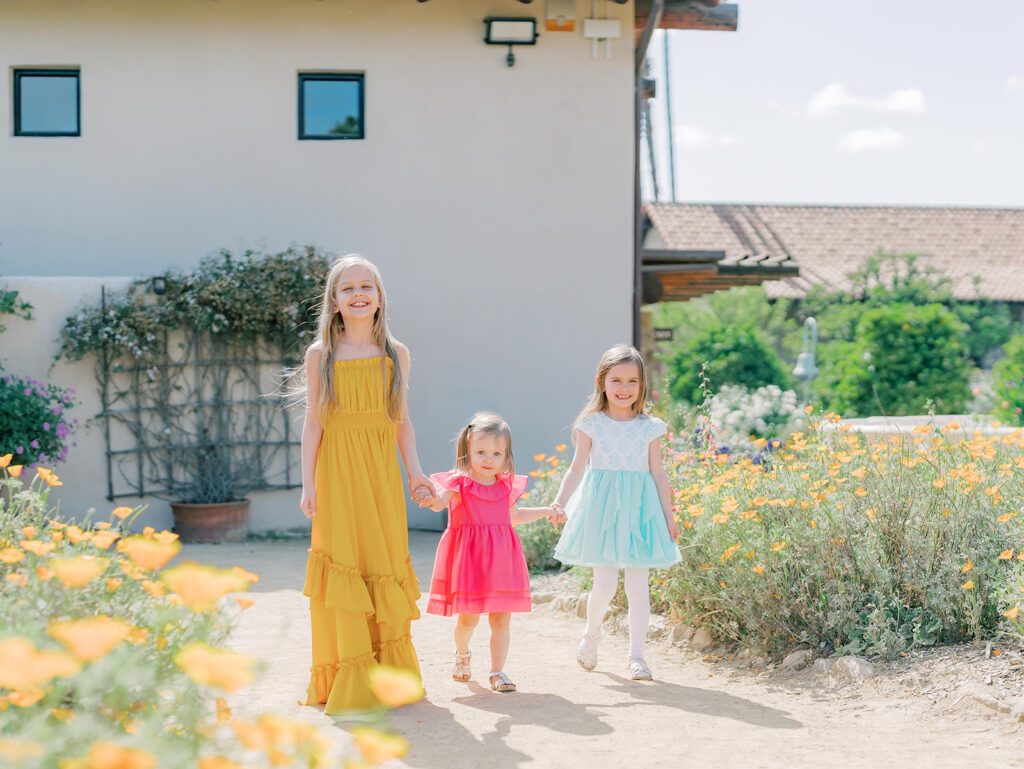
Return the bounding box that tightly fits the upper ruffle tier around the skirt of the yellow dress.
[302,550,420,625]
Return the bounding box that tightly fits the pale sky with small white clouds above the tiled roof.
[642,0,1024,207]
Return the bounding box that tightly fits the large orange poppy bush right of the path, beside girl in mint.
[652,415,1024,657]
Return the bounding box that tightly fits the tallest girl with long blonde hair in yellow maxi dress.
[299,255,433,714]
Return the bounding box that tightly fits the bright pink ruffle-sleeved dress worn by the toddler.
[427,472,530,616]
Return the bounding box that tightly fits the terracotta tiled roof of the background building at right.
[645,203,1024,301]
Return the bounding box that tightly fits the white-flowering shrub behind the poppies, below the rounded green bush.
[709,385,805,455]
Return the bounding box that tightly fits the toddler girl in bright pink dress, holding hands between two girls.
[421,412,564,692]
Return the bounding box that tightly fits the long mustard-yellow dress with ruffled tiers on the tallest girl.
[303,357,420,714]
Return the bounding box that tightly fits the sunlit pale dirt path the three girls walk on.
[182,531,1024,769]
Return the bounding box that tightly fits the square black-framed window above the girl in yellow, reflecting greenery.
[299,73,366,139]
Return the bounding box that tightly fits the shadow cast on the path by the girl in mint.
[599,672,803,729]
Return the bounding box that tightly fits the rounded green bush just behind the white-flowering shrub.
[670,325,790,403]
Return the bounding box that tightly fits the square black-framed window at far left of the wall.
[14,69,82,136]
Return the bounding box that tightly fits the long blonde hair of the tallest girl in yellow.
[314,254,406,424]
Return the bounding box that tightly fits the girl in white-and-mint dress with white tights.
[551,345,680,680]
